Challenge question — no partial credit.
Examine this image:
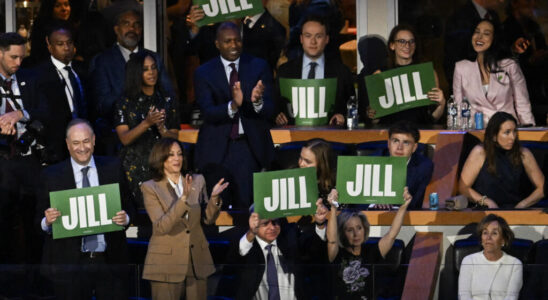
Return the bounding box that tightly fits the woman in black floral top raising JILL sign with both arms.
[322,187,413,299]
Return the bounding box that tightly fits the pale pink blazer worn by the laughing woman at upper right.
[453,59,535,126]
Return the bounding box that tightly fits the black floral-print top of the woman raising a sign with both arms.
[333,244,384,300]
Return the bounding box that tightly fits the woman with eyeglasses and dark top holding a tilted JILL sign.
[367,24,445,125]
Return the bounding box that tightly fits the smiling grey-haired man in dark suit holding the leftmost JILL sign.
[36,119,129,299]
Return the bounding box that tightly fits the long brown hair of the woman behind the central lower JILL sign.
[304,139,335,194]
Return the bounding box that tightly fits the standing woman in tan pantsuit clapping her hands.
[141,138,228,300]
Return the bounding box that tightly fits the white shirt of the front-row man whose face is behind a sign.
[240,234,297,300]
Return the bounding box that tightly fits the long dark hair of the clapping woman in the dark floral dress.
[124,50,164,100]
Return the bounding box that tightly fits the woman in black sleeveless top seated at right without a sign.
[459,112,544,208]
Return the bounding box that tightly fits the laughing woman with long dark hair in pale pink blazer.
[453,20,535,125]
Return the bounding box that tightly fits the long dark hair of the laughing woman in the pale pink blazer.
[468,20,513,73]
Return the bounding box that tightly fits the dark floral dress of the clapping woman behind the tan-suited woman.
[114,92,179,208]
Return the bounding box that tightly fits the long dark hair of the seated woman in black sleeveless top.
[483,111,522,176]
